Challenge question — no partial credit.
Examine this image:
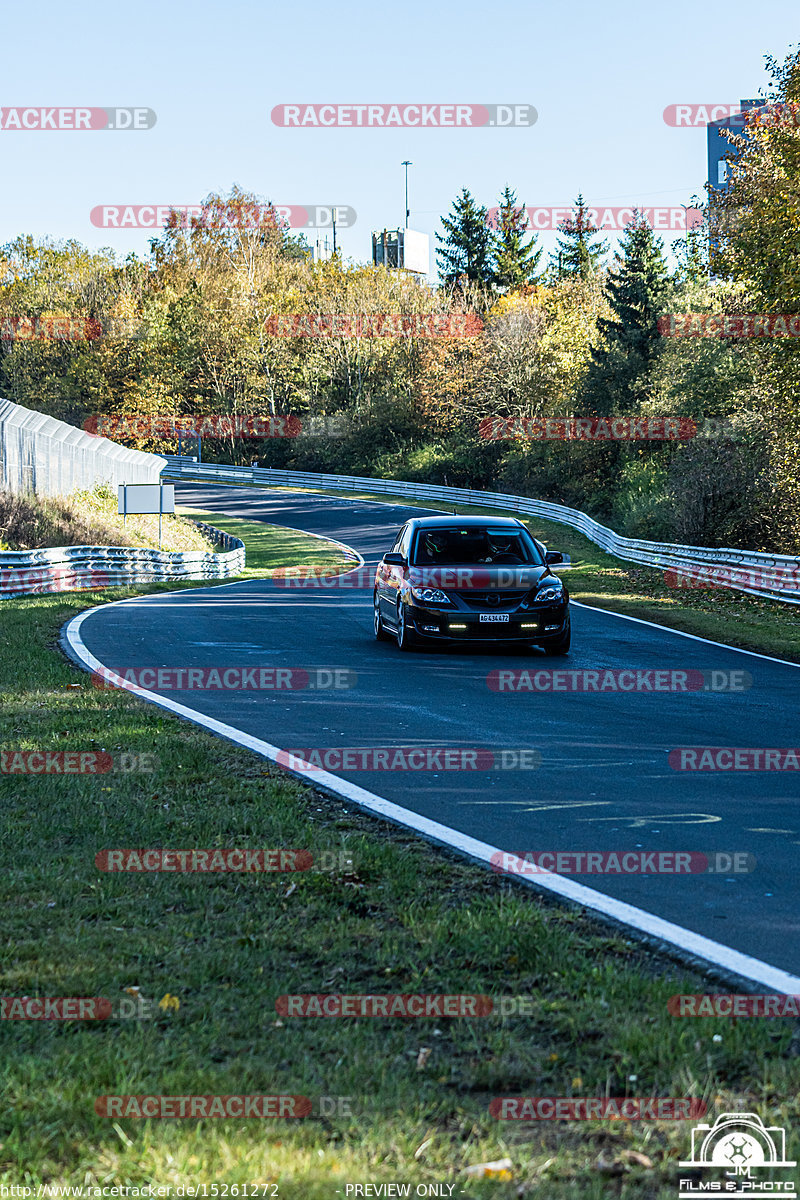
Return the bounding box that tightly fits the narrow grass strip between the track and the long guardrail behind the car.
[244,488,800,662]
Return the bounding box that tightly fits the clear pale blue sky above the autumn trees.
[0,0,798,276]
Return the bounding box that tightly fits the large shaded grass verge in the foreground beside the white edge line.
[0,517,800,1200]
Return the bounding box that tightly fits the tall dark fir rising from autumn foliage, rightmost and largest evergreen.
[583,210,672,414]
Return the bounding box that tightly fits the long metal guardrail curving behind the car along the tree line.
[162,455,800,604]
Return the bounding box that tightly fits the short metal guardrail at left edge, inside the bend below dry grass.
[0,521,245,600]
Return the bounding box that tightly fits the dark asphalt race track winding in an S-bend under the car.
[64,484,800,990]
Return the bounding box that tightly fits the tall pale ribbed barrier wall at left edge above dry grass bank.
[0,400,166,496]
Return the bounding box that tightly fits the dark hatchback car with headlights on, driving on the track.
[373,516,570,655]
